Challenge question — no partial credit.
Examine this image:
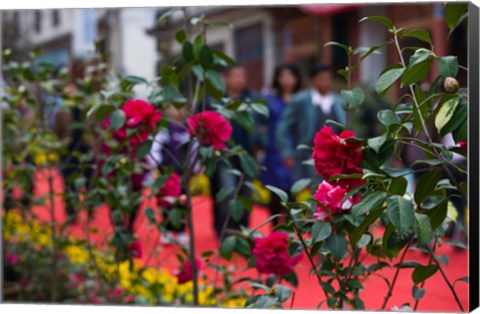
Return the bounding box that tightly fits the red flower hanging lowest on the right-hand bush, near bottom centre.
[252,231,302,276]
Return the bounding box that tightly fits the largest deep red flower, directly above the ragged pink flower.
[312,126,365,190]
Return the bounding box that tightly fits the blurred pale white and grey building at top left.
[2,8,158,97]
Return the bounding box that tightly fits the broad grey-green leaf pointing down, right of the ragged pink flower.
[387,195,415,233]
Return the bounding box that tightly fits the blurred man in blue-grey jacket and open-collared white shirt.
[276,65,346,182]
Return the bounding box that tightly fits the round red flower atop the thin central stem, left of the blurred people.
[187,111,232,149]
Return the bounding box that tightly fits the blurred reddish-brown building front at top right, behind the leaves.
[148,2,467,93]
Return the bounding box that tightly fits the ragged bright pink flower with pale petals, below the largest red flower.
[313,181,359,221]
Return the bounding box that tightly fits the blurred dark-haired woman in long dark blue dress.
[259,64,302,225]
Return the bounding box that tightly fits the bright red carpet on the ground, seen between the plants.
[25,168,468,312]
